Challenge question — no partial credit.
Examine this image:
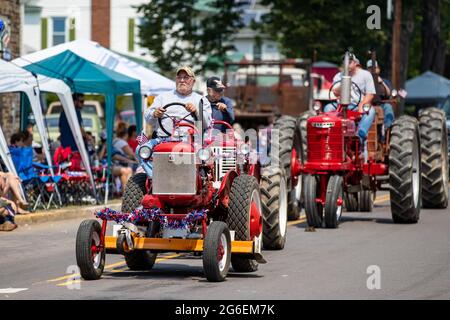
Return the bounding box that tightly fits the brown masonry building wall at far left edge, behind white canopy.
[0,0,21,139]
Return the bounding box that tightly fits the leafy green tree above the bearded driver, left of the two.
[137,0,242,73]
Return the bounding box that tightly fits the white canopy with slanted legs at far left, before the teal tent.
[0,60,95,196]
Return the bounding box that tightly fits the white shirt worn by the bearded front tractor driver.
[144,90,212,137]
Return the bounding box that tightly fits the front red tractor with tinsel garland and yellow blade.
[76,103,286,281]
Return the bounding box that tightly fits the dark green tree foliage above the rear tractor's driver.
[260,0,391,63]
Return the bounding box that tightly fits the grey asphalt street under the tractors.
[0,194,450,300]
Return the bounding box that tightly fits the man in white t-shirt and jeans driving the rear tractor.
[324,53,376,158]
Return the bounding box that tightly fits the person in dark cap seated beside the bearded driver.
[206,77,234,133]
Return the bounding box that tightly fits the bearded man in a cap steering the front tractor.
[142,66,212,176]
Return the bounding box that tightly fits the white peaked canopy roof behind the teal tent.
[13,39,175,95]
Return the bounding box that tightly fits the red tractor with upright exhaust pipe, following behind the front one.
[289,53,448,228]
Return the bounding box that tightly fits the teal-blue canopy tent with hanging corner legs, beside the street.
[22,50,142,202]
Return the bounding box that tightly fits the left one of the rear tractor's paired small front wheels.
[303,174,323,228]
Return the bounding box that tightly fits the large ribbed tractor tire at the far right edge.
[419,108,448,209]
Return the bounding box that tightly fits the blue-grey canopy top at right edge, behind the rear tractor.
[405,71,450,104]
